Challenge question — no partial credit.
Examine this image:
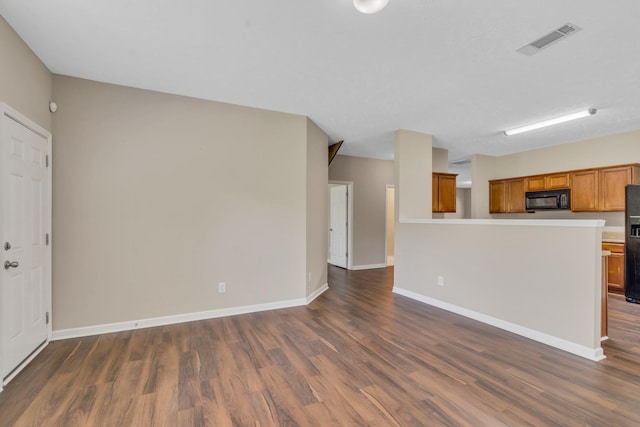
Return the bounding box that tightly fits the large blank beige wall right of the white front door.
[53,76,327,330]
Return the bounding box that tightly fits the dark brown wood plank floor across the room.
[0,266,640,427]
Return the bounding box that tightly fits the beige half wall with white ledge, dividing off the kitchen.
[394,221,601,357]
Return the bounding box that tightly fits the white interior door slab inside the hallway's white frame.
[329,185,348,268]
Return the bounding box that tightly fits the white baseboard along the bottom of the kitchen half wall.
[393,287,606,361]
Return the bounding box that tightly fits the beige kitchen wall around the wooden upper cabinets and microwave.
[472,131,640,226]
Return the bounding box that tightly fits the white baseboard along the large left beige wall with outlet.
[52,298,308,341]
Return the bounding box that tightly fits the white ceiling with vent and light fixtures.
[0,0,640,186]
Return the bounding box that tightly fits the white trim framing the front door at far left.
[0,102,53,392]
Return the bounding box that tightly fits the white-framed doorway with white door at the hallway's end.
[327,182,353,269]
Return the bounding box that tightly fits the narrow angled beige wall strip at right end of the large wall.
[306,119,329,295]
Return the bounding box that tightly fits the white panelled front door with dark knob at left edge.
[0,105,51,389]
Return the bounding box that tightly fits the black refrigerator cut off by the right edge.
[624,185,640,304]
